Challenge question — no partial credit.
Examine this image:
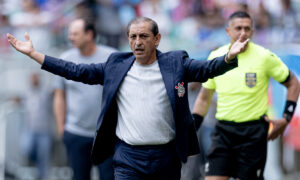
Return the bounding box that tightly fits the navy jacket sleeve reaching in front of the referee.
[182,50,238,82]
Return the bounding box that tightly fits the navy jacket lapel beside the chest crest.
[157,51,175,112]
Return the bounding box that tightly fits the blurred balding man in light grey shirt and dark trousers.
[53,18,116,180]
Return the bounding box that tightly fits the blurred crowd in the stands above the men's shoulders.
[0,0,300,56]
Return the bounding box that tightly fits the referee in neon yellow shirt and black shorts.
[193,11,300,180]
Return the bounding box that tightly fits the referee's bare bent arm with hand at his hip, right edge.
[265,72,300,140]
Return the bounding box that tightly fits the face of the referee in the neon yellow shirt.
[226,18,253,43]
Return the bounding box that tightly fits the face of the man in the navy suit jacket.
[128,22,161,64]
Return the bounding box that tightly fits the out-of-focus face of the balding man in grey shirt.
[69,19,91,49]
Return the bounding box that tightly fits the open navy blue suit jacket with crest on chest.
[42,51,237,164]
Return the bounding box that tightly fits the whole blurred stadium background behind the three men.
[0,0,300,180]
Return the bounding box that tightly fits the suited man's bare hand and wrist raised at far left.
[6,33,45,65]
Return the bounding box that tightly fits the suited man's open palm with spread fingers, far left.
[7,33,34,55]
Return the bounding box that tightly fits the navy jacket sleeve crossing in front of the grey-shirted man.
[42,56,106,85]
